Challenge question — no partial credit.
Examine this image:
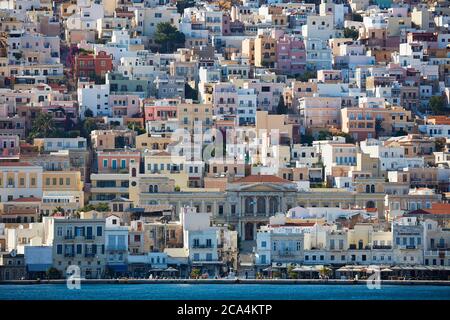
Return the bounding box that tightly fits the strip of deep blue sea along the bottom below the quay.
[0,284,450,300]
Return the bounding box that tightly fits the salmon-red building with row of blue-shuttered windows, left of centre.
[97,150,141,173]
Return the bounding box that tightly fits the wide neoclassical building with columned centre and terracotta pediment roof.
[129,170,385,241]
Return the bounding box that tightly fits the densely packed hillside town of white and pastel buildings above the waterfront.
[0,0,450,281]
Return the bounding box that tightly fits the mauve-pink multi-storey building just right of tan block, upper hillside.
[275,35,306,74]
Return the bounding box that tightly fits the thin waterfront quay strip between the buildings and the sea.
[0,279,450,286]
